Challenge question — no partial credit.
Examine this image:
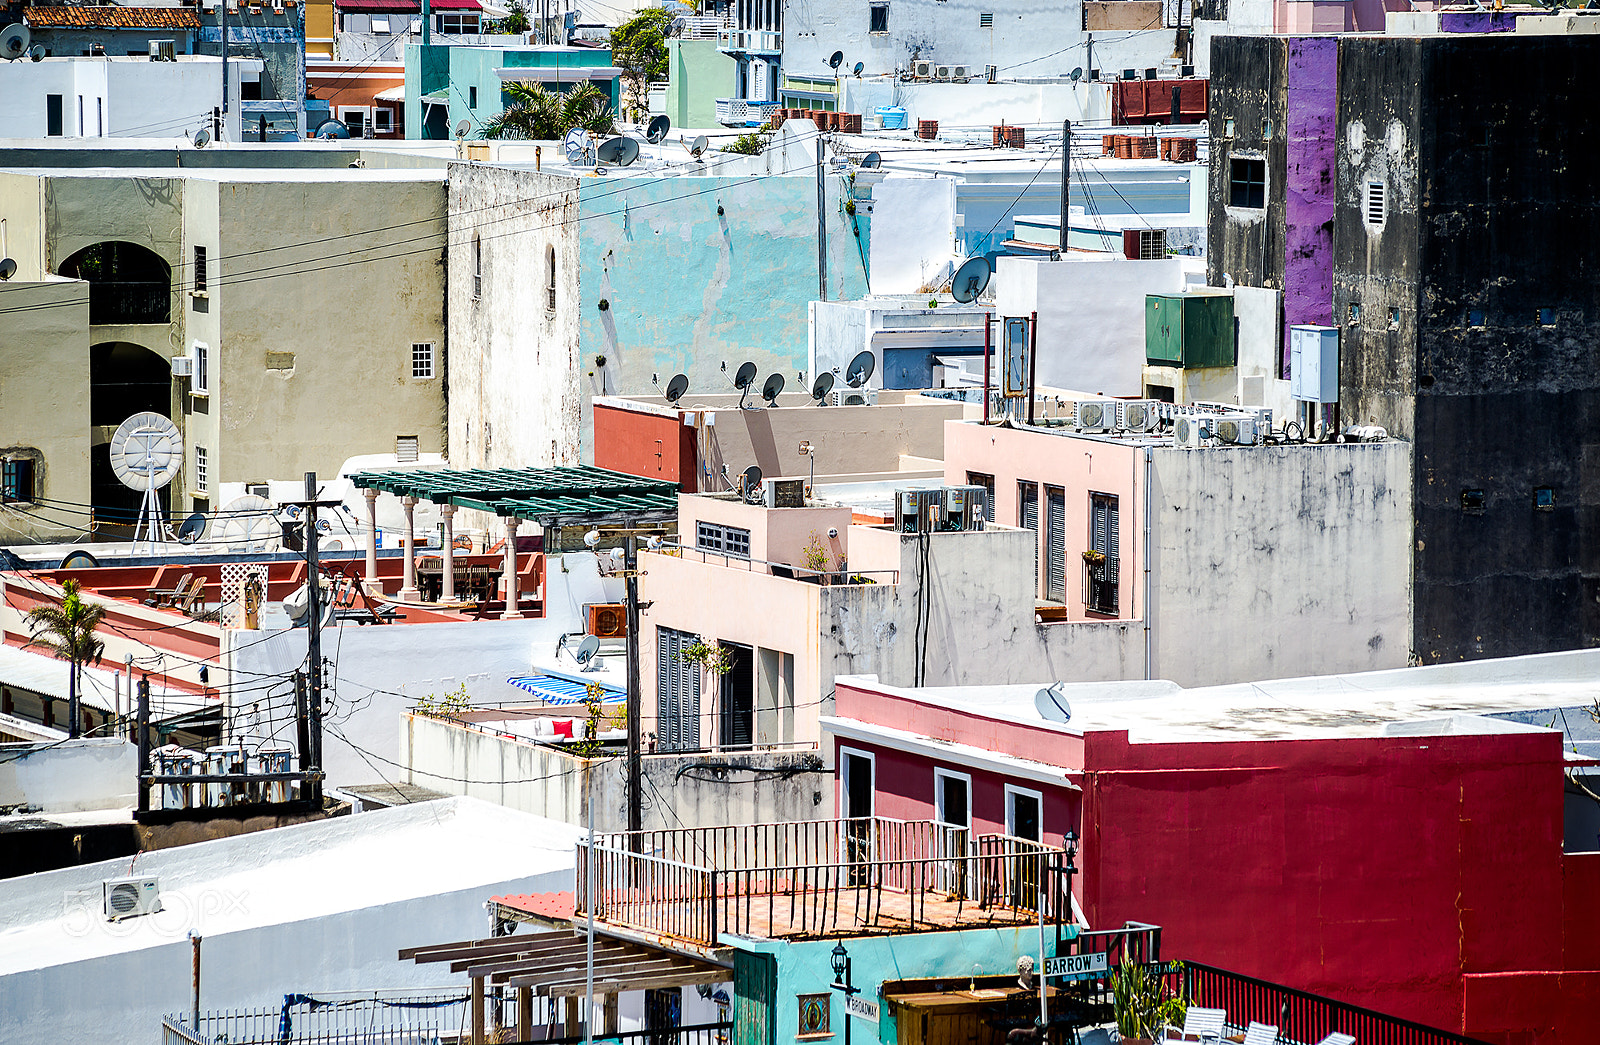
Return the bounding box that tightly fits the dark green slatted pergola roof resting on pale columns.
[350,466,678,527]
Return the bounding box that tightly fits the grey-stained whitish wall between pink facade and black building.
[1150,440,1411,687]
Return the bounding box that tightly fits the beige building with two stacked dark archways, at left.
[0,166,445,541]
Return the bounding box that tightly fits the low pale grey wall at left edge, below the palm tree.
[0,738,139,813]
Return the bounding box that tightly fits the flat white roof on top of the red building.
[837,650,1600,744]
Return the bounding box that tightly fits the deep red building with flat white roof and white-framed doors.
[824,653,1600,1045]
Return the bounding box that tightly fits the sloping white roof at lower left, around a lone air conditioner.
[0,799,581,978]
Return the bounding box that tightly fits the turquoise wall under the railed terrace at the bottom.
[722,925,1077,1045]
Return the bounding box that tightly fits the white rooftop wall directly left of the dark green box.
[995,254,1184,395]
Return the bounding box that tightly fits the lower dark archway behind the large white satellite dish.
[90,341,173,536]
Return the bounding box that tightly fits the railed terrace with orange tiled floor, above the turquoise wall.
[576,816,1069,949]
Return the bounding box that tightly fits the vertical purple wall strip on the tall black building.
[1278,37,1339,378]
